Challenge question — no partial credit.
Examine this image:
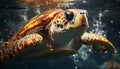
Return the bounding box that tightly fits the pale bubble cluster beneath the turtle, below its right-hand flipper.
[72,44,92,69]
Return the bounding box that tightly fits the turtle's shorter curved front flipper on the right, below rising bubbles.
[80,33,117,53]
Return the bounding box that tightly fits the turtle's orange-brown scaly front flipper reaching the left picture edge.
[0,33,43,62]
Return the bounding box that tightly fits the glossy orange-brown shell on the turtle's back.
[10,9,63,41]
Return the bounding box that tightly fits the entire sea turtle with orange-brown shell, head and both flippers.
[0,9,117,62]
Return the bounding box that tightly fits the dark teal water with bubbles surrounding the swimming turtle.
[0,0,120,69]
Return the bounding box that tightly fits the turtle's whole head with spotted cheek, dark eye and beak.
[49,9,88,40]
